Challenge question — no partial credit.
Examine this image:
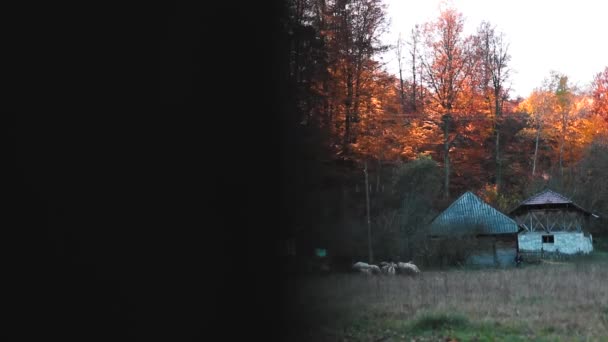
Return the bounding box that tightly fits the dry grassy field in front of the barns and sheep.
[284,251,608,341]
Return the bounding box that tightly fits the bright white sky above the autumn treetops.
[383,0,608,98]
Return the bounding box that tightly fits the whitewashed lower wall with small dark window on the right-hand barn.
[517,232,593,254]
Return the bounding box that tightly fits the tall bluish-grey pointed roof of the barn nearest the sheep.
[430,191,518,235]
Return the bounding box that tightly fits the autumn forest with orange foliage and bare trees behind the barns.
[278,0,608,268]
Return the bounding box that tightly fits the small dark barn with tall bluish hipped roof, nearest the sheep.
[429,191,518,266]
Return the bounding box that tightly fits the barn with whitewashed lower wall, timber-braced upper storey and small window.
[509,189,598,254]
